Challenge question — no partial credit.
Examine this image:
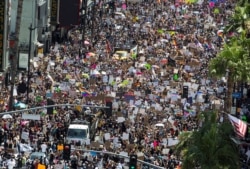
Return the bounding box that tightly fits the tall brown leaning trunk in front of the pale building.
[9,0,23,110]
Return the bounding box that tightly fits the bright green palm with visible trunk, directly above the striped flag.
[209,37,250,113]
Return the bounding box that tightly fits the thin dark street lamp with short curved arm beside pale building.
[26,24,48,103]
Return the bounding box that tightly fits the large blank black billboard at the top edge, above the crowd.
[59,0,80,27]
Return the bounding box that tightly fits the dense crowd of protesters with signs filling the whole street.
[0,0,248,169]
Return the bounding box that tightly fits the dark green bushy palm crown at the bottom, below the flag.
[175,112,239,169]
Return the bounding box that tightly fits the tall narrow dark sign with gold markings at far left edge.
[0,0,5,69]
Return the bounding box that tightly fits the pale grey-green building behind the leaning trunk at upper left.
[8,0,50,69]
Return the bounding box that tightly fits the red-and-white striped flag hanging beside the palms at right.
[228,114,247,138]
